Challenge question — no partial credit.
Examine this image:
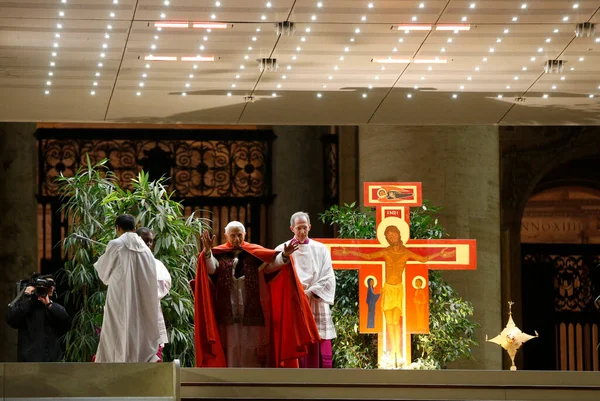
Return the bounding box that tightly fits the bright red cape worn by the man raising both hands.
[191,242,320,368]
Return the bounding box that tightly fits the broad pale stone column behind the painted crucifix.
[359,126,503,369]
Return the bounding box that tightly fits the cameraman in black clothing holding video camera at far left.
[6,274,70,362]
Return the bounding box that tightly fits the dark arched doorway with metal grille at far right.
[521,184,600,370]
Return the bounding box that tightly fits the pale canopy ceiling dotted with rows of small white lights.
[0,0,600,125]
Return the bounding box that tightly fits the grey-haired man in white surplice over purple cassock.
[275,212,336,368]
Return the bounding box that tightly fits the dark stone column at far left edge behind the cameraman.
[0,123,38,362]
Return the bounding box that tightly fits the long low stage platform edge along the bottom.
[0,363,600,401]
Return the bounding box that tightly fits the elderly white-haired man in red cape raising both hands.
[192,221,319,367]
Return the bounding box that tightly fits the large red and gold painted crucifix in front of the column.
[317,182,477,368]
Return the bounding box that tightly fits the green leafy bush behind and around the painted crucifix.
[320,201,478,369]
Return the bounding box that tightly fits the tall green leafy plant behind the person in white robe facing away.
[58,158,208,366]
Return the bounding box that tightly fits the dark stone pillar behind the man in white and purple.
[266,126,329,247]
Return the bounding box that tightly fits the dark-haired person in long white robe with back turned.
[94,214,160,363]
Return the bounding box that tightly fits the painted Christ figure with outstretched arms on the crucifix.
[334,226,455,359]
